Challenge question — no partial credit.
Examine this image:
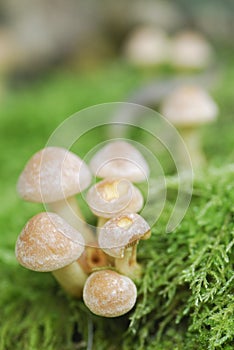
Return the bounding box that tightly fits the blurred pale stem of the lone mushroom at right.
[179,127,206,168]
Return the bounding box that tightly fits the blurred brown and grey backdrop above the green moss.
[0,0,234,86]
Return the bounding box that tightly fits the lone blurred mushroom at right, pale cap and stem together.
[161,86,218,167]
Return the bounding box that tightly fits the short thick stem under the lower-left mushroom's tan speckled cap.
[52,261,88,298]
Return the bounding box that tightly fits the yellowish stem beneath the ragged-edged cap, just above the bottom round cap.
[115,243,142,280]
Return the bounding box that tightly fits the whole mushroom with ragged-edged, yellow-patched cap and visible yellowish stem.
[98,213,150,279]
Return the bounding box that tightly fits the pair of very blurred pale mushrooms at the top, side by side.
[123,25,214,70]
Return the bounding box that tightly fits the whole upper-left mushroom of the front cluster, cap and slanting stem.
[17,147,94,242]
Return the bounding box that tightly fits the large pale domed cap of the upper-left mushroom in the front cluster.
[17,147,92,203]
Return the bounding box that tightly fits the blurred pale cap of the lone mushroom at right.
[161,86,218,127]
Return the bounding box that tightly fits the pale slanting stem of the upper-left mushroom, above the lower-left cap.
[48,196,95,243]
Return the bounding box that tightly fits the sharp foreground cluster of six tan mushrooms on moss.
[15,140,150,317]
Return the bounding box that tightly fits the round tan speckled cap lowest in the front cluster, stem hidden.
[83,270,137,317]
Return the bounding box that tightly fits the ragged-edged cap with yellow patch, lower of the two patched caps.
[98,213,150,258]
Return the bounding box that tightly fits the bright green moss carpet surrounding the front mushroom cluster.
[0,53,234,350]
